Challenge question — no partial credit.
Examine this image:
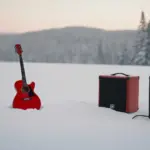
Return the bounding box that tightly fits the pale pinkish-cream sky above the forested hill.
[0,0,150,32]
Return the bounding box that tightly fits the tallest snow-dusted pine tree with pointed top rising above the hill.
[130,11,147,65]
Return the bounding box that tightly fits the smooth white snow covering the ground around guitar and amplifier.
[0,63,150,150]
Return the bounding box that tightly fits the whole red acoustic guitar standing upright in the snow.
[13,44,41,110]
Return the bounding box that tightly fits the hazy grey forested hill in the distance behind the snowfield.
[0,27,136,64]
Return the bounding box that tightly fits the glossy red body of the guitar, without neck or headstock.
[13,80,41,110]
